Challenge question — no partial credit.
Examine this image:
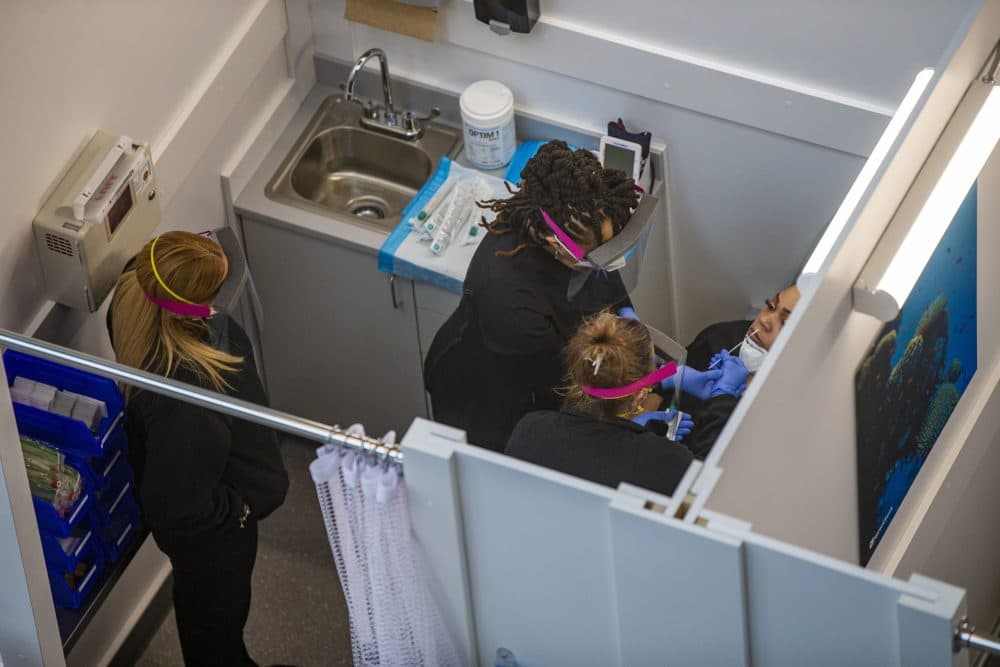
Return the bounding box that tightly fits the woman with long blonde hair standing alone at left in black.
[108,231,288,666]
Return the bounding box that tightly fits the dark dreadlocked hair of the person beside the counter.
[479,140,639,256]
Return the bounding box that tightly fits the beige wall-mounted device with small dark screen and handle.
[33,130,160,312]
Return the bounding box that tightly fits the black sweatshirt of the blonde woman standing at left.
[109,315,288,550]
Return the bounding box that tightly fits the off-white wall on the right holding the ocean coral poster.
[706,0,1000,629]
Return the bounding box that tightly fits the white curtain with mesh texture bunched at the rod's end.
[309,424,458,667]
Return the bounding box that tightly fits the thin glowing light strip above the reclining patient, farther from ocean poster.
[796,69,934,289]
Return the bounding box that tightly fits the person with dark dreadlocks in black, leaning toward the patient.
[424,141,638,451]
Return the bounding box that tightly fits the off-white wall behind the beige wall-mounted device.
[0,0,311,347]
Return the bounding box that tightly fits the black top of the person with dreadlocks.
[424,232,630,451]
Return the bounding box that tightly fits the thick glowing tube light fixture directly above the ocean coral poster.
[854,80,1000,322]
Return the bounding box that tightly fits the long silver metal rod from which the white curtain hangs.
[0,329,403,463]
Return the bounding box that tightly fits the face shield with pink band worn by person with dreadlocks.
[541,195,657,299]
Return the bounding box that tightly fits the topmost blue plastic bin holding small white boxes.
[3,350,125,457]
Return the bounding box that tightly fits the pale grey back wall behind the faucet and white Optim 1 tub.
[310,0,969,342]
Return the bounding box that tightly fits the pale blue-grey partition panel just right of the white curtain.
[458,451,624,667]
